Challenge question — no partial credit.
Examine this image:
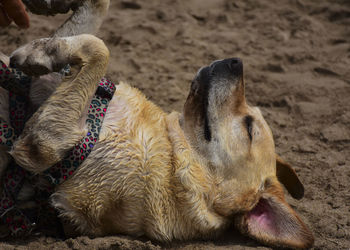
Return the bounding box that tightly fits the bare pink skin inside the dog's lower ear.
[248,199,279,234]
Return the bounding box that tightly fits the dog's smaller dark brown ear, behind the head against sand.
[276,154,304,200]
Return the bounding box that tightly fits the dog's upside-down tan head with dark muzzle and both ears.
[183,58,313,248]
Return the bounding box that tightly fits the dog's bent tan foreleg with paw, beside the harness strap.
[10,35,109,172]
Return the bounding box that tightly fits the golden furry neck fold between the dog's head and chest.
[167,112,227,237]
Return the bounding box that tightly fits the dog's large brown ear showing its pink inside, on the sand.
[236,181,314,249]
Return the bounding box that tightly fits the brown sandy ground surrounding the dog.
[0,0,350,249]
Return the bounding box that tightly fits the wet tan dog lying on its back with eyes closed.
[5,32,314,248]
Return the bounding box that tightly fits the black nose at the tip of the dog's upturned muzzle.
[210,58,243,77]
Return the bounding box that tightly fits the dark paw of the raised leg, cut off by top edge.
[22,0,82,16]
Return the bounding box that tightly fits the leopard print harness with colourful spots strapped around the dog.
[0,61,116,236]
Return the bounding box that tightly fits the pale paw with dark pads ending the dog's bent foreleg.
[10,38,64,76]
